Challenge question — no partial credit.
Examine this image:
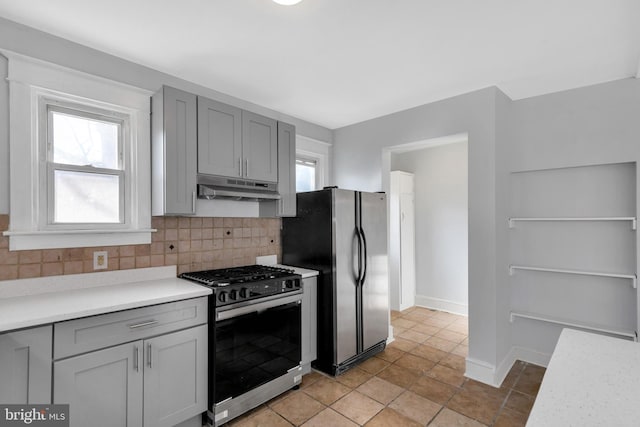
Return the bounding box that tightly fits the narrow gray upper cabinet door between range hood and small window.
[277,122,296,216]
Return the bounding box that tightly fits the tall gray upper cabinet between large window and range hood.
[151,86,198,215]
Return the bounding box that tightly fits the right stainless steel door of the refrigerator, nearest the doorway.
[361,193,389,350]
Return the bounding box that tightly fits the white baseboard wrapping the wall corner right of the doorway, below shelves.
[464,347,551,387]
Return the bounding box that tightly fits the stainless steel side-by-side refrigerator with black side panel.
[282,188,389,375]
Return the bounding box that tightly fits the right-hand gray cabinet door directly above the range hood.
[242,111,278,182]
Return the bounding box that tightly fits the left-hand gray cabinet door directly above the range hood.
[198,97,242,177]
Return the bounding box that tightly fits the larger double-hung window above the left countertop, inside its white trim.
[43,101,128,228]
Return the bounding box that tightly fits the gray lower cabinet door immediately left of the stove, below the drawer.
[144,325,208,427]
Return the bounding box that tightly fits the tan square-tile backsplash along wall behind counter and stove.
[0,215,281,280]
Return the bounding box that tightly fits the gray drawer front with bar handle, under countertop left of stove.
[53,297,207,359]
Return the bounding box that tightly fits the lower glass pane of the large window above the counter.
[53,170,120,223]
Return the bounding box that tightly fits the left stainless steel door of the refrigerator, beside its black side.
[333,189,358,364]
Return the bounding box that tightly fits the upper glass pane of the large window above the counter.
[51,111,120,169]
